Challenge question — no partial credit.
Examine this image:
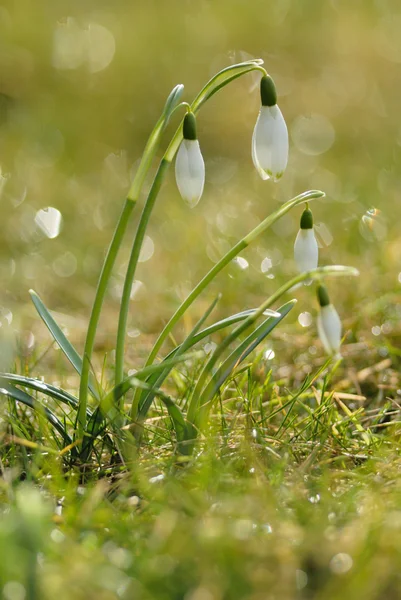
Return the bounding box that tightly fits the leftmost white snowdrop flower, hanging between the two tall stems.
[175,112,205,208]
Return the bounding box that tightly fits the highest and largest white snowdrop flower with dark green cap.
[252,75,288,181]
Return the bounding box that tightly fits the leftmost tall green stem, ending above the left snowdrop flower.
[77,91,183,439]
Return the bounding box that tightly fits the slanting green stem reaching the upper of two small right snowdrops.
[146,190,324,366]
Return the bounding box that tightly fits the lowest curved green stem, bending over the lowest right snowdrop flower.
[187,265,359,431]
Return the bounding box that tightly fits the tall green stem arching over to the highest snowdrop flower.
[115,59,265,400]
